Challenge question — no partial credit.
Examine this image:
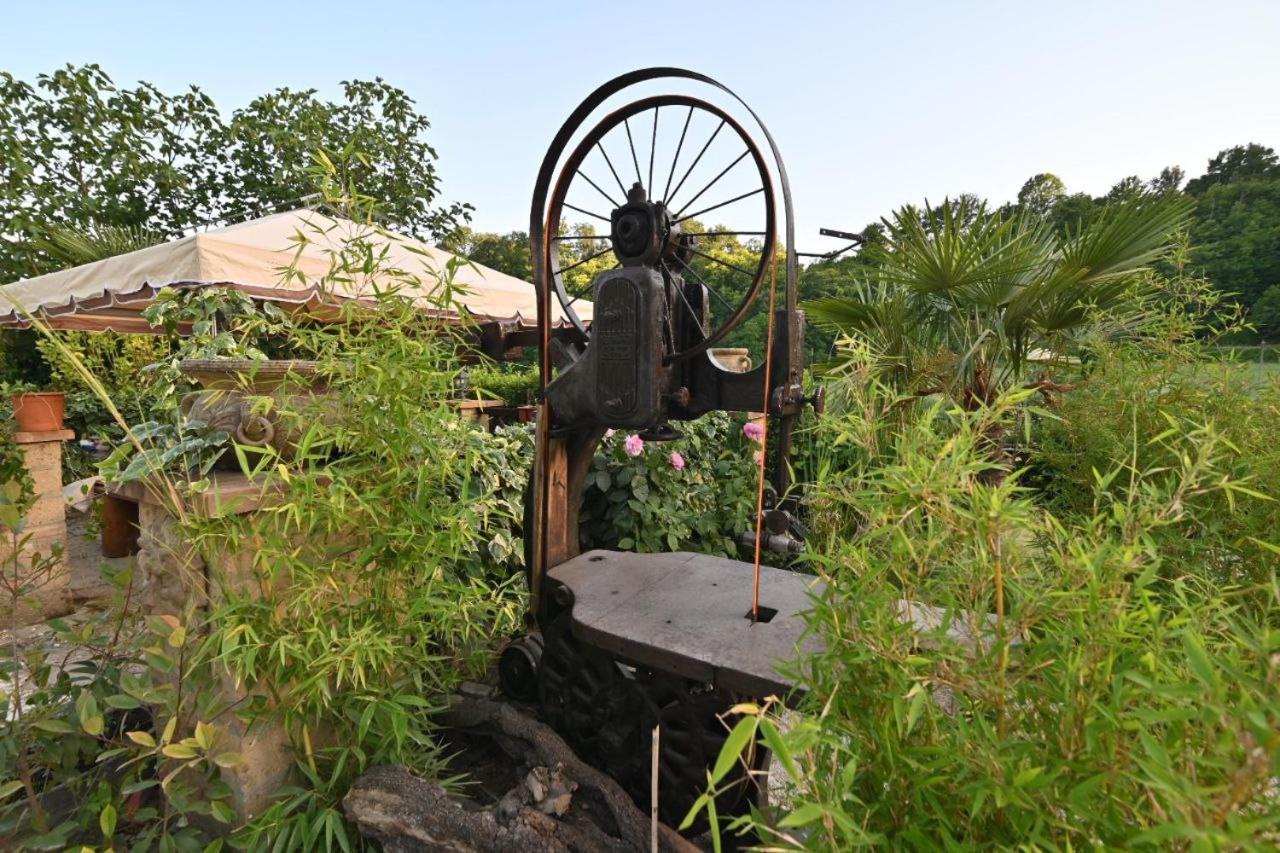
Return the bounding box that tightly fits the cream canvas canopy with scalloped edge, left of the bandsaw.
[0,210,590,332]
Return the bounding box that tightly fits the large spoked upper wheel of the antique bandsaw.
[544,95,777,362]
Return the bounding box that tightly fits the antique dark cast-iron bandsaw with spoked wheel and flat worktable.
[499,68,822,825]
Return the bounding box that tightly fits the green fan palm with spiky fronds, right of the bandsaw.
[805,195,1192,410]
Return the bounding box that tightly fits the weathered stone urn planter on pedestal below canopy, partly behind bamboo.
[178,359,328,467]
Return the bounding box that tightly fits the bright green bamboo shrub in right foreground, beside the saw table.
[703,376,1280,850]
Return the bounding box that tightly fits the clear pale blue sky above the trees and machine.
[0,0,1280,251]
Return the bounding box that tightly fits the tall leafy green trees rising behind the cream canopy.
[0,65,470,282]
